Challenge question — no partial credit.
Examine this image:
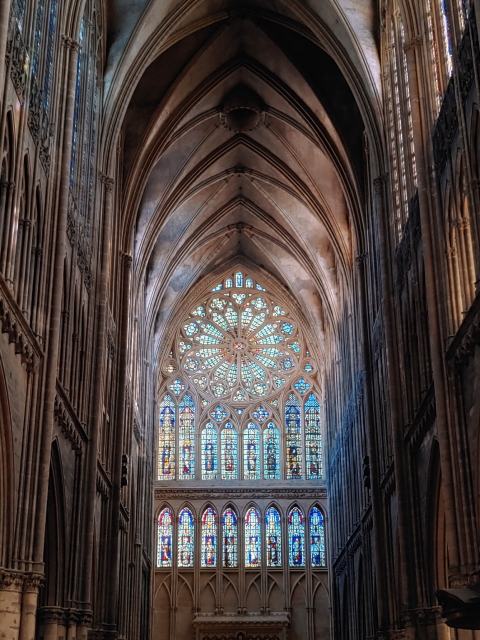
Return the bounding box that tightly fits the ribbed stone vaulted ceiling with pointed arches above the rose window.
[105,0,380,362]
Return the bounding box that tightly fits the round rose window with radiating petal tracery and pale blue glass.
[177,274,300,402]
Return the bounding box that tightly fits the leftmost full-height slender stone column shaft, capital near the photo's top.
[33,31,80,572]
